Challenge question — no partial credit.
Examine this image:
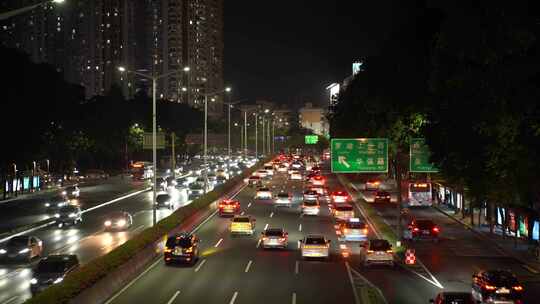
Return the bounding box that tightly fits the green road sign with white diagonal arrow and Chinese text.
[330,138,388,173]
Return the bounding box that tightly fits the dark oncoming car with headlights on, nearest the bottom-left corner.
[30,254,79,294]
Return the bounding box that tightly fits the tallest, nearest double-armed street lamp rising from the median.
[118,66,178,226]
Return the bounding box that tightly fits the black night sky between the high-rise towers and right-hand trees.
[224,0,407,104]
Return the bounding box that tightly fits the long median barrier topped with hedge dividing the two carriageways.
[25,158,271,304]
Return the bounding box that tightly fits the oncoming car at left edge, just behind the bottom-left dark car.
[0,235,43,262]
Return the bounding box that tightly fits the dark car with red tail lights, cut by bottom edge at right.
[472,269,524,304]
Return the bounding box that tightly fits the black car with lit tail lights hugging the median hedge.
[163,233,200,265]
